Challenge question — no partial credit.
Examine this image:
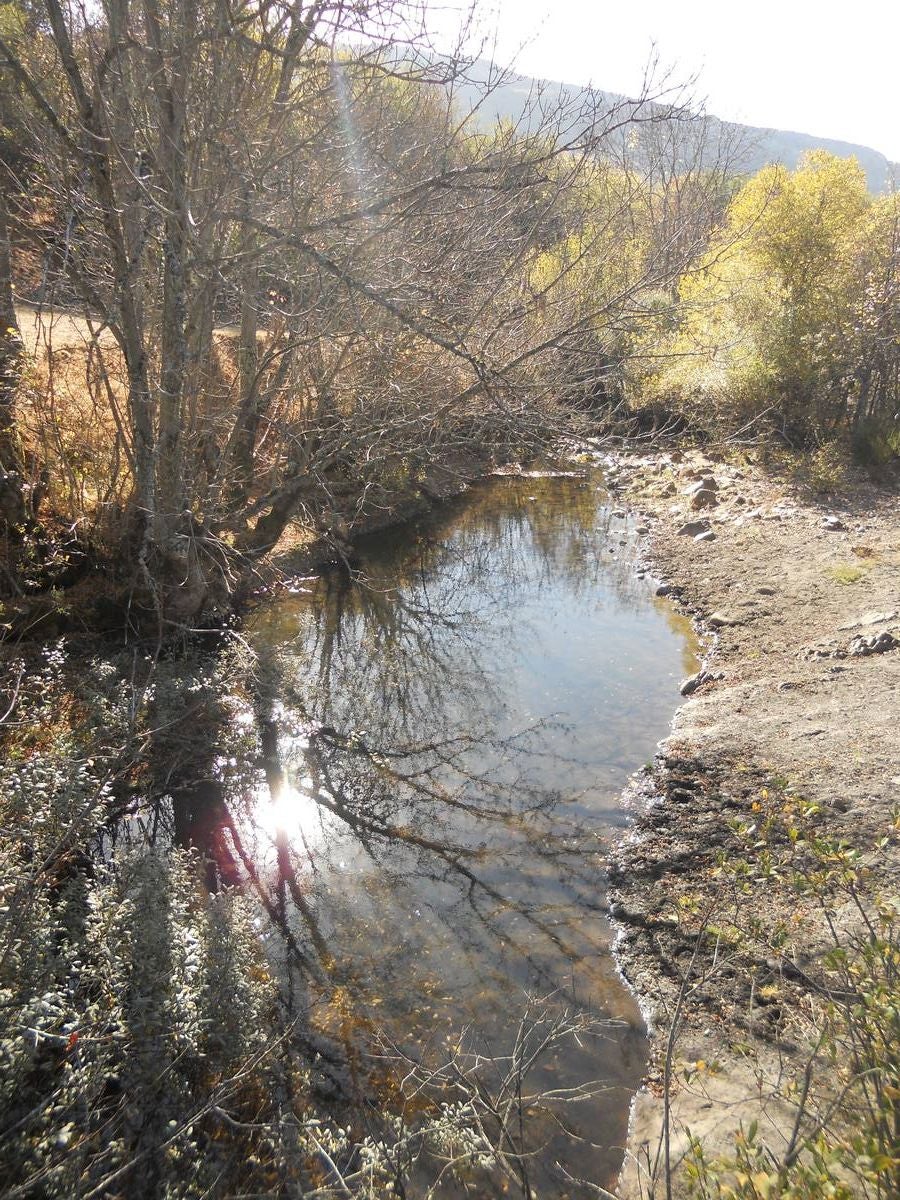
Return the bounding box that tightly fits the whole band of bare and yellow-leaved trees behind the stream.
[0,0,900,632]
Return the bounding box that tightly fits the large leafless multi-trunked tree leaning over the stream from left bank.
[0,0,715,624]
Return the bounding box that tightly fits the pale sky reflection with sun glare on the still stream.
[247,479,694,1195]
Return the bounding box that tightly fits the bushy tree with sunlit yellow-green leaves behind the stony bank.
[656,150,896,444]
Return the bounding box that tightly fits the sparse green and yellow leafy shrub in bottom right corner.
[661,779,900,1200]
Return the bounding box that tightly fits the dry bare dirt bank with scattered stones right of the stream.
[611,452,900,1198]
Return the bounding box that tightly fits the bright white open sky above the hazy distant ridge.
[438,0,900,162]
